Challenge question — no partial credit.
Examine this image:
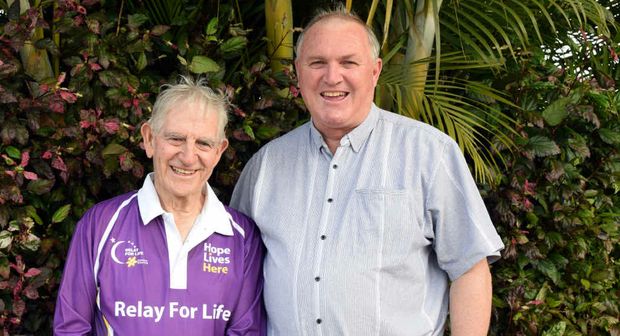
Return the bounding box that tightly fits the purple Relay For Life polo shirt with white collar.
[54,177,265,336]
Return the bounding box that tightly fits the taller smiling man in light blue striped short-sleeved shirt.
[231,5,503,336]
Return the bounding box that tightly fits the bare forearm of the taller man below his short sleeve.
[450,258,493,336]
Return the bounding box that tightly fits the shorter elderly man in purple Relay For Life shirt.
[54,78,265,336]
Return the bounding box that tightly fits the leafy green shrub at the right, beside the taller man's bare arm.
[488,46,620,335]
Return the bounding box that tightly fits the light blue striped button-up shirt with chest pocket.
[231,105,503,335]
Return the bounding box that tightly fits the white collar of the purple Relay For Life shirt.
[138,173,233,236]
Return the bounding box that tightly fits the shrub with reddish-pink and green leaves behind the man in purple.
[0,0,304,335]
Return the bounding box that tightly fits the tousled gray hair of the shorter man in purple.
[148,76,229,140]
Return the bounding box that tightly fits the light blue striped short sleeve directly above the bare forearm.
[425,141,504,280]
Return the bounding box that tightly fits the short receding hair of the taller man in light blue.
[295,3,381,59]
